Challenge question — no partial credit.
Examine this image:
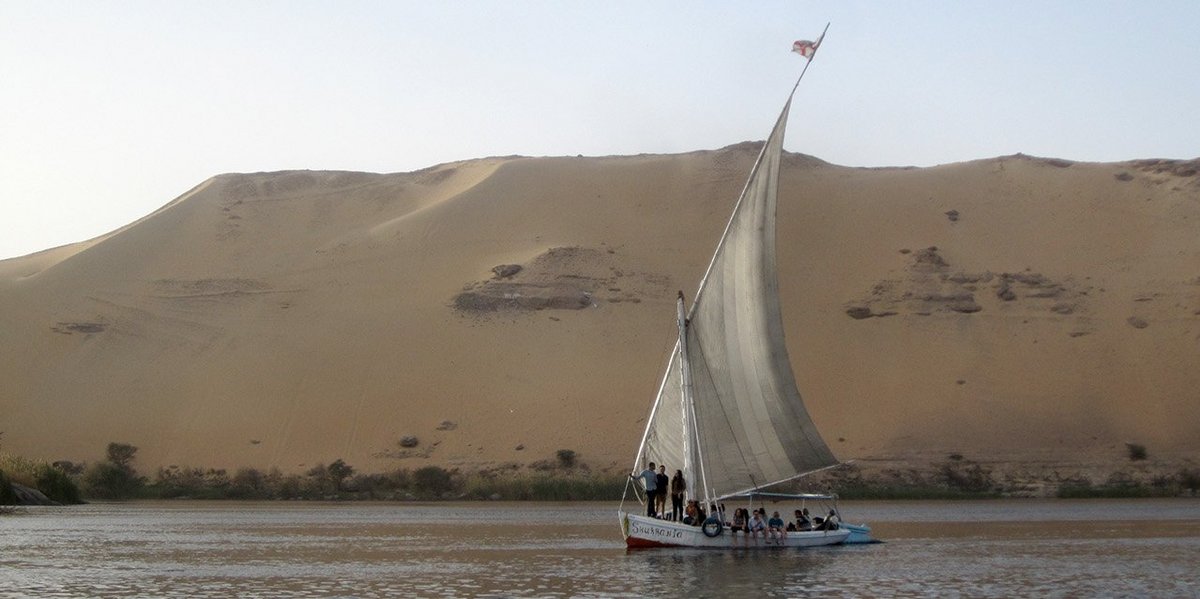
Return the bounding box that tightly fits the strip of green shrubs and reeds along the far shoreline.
[7,443,1200,505]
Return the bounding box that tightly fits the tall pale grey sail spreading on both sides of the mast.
[638,89,838,498]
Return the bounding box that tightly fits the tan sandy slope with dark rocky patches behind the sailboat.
[0,144,1200,471]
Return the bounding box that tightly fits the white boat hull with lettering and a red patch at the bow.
[617,511,851,549]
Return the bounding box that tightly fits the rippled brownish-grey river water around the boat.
[0,499,1200,598]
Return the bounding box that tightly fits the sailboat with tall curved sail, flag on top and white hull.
[618,31,870,547]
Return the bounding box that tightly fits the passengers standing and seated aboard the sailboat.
[630,462,838,544]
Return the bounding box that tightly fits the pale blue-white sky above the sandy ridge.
[0,0,1200,258]
